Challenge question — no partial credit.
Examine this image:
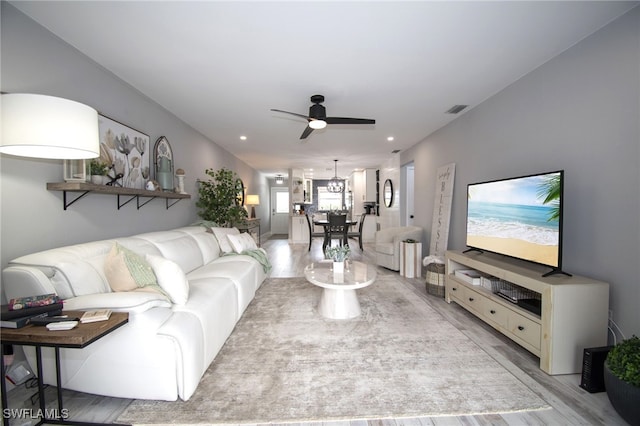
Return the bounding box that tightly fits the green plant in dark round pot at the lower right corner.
[604,335,640,425]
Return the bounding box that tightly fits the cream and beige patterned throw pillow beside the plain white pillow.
[104,242,164,293]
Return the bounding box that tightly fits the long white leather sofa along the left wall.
[2,226,268,401]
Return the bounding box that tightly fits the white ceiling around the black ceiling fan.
[11,1,638,177]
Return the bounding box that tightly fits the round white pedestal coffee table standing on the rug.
[304,261,377,319]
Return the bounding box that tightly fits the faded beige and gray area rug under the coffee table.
[117,276,549,425]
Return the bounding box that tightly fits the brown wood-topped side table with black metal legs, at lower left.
[0,311,129,426]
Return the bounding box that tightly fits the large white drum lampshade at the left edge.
[0,93,100,160]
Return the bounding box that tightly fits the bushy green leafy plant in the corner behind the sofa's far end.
[196,167,247,226]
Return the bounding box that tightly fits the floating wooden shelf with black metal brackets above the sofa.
[47,182,191,210]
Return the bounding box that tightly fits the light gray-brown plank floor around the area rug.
[2,239,626,426]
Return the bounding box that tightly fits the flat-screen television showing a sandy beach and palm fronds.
[467,173,561,266]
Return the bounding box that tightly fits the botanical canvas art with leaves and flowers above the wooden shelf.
[98,115,150,189]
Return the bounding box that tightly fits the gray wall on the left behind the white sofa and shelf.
[0,2,269,268]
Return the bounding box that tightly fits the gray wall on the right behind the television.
[401,8,640,337]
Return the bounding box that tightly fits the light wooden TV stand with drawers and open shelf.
[445,251,609,374]
